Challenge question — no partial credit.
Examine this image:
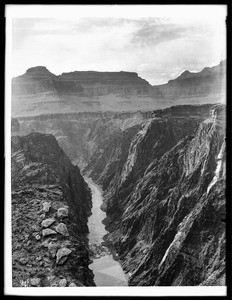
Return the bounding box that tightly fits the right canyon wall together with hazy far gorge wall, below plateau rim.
[11,104,225,286]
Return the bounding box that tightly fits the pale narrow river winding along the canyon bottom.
[85,178,128,286]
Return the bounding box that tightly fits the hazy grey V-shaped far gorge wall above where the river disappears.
[12,112,151,168]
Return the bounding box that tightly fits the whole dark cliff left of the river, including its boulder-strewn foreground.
[11,132,94,286]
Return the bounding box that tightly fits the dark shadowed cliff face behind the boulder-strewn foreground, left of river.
[12,133,91,232]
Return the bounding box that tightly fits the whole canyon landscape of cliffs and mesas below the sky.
[11,62,226,286]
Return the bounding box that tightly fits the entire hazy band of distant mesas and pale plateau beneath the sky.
[12,61,226,117]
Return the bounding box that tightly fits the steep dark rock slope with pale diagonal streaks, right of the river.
[84,105,225,285]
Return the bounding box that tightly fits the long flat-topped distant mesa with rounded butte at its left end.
[12,66,150,97]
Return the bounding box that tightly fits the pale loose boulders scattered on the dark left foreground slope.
[19,202,83,287]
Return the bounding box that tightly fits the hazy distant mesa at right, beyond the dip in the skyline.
[152,60,226,99]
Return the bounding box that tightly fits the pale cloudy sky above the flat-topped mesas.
[7,5,226,85]
